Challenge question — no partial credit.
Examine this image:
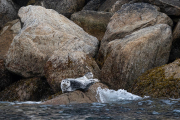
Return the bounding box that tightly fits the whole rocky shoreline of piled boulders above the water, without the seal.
[0,0,180,104]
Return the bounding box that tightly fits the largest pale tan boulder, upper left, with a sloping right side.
[6,5,99,78]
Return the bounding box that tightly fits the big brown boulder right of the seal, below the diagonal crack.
[101,24,172,90]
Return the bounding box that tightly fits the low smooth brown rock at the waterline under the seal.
[42,83,107,105]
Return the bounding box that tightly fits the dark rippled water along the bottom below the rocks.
[0,99,180,120]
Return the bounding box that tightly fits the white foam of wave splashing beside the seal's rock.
[96,87,142,103]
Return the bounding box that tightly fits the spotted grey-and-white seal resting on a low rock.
[61,72,99,93]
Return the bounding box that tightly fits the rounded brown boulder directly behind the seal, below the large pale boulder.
[45,50,100,93]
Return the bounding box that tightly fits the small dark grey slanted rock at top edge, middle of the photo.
[83,0,106,11]
